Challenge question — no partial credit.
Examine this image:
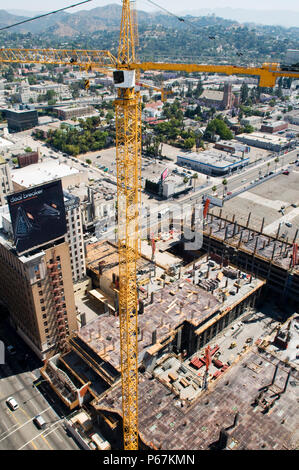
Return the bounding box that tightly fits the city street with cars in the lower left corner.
[0,324,79,450]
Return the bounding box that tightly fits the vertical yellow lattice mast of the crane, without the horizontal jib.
[115,0,141,450]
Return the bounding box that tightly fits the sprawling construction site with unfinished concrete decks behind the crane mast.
[41,207,299,450]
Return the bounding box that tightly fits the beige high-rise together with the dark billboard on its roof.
[0,182,77,359]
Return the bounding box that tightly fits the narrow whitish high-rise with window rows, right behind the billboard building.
[64,192,86,282]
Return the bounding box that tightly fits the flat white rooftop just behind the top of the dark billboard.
[11,159,79,188]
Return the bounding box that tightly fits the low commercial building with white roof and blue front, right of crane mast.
[177,150,249,176]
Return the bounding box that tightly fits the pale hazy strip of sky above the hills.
[6,0,299,13]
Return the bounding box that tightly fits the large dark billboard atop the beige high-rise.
[7,180,67,253]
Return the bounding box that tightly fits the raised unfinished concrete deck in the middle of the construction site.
[78,262,264,370]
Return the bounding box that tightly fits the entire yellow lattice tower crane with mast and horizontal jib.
[0,0,299,450]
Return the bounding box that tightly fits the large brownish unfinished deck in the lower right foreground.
[94,345,299,450]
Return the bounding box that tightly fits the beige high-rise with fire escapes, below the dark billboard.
[0,218,77,360]
